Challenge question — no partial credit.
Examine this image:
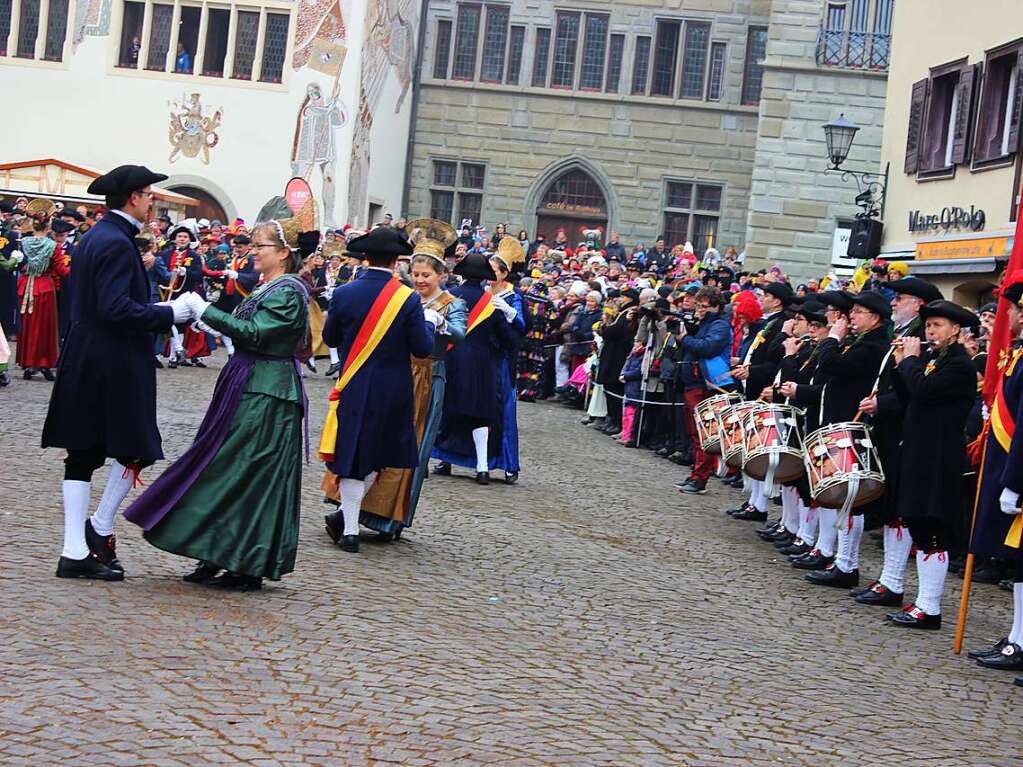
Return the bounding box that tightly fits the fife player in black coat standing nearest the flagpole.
[888,300,978,629]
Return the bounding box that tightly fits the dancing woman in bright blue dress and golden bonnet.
[489,237,526,485]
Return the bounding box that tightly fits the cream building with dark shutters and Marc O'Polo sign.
[882,0,1023,306]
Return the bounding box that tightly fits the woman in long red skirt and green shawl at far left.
[17,221,69,380]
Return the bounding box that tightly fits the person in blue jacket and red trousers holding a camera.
[673,287,735,495]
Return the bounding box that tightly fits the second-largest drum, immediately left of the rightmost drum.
[743,402,806,485]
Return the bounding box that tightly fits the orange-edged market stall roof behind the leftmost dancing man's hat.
[0,157,199,211]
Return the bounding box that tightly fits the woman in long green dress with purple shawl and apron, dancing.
[125,219,309,590]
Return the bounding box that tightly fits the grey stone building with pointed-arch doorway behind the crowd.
[406,0,892,273]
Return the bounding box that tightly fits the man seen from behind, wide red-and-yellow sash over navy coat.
[320,226,433,553]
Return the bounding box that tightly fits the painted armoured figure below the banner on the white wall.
[292,83,348,226]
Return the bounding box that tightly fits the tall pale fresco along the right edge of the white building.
[348,0,419,224]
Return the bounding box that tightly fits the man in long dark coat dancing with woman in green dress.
[42,165,191,581]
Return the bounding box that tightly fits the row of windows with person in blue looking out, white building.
[106,0,292,85]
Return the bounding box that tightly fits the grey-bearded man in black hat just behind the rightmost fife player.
[850,277,941,606]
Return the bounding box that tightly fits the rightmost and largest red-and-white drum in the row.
[803,421,885,509]
